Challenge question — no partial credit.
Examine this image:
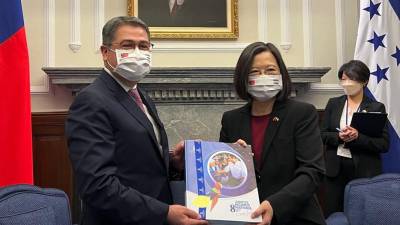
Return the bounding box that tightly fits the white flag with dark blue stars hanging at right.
[354,0,400,173]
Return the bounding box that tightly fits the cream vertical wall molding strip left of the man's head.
[68,0,82,52]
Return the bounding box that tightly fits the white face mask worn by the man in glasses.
[107,48,151,81]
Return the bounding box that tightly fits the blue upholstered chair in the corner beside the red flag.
[0,185,71,225]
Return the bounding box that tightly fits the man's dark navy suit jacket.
[66,71,171,225]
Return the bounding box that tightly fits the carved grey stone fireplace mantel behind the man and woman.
[43,67,330,104]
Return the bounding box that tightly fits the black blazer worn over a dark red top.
[220,100,325,224]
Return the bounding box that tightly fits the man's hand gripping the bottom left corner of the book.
[167,205,208,225]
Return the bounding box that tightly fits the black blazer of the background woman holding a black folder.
[321,95,389,178]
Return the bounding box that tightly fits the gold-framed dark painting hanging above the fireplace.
[128,0,239,39]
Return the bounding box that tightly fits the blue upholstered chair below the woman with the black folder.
[326,174,400,225]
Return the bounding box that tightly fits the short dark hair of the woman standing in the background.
[338,60,370,83]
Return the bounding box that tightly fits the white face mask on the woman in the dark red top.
[247,74,282,102]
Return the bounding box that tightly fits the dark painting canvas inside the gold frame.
[138,0,227,27]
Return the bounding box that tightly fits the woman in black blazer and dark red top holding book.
[220,42,325,225]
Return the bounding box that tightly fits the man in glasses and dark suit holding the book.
[66,17,207,225]
